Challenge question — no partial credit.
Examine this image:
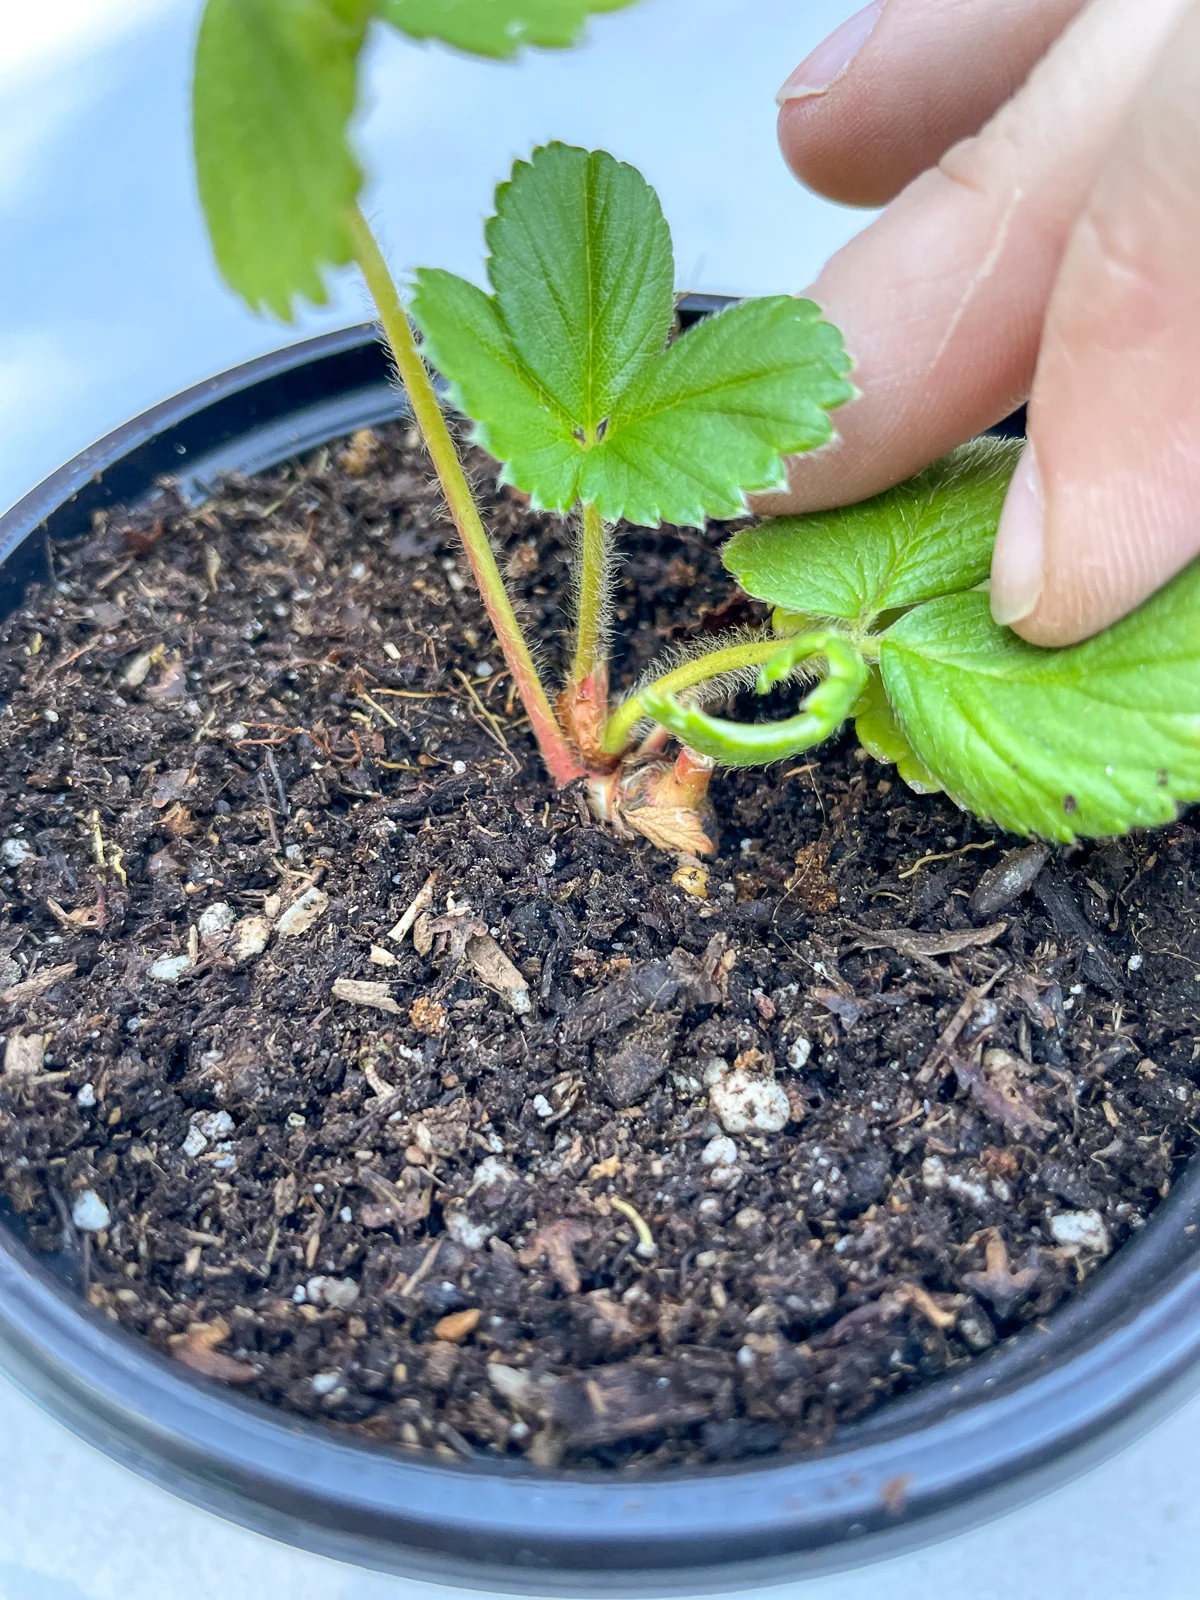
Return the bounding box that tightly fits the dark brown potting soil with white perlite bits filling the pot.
[0,427,1200,1467]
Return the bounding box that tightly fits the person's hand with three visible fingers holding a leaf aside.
[754,0,1200,645]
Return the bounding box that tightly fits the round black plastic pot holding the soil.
[0,301,1200,1595]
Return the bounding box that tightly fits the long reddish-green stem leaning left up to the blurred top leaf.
[349,206,582,784]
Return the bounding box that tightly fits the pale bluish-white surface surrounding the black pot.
[0,0,1200,1600]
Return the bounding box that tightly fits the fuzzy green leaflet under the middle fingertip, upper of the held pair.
[722,438,1021,626]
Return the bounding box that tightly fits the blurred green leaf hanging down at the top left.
[192,0,374,320]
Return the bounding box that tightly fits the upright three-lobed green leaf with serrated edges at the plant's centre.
[411,144,853,526]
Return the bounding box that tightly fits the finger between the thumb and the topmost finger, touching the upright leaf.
[754,0,1184,515]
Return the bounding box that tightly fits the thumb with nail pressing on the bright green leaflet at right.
[992,0,1200,645]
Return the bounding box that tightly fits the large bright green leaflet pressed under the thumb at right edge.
[880,576,1200,842]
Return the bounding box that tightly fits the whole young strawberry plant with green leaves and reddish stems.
[194,0,1200,853]
